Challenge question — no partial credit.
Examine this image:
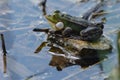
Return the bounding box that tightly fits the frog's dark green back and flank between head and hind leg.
[60,14,91,31]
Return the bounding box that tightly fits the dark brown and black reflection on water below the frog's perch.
[49,50,103,71]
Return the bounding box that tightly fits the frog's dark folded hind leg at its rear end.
[80,27,103,41]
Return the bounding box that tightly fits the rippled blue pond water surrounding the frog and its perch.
[0,0,120,80]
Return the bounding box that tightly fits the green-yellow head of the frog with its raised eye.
[45,10,63,30]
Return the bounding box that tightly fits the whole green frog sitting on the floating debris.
[45,10,104,41]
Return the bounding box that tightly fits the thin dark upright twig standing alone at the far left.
[1,34,7,73]
